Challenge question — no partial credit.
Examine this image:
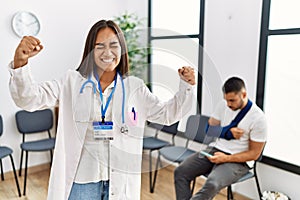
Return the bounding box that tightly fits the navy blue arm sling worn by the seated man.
[206,99,252,140]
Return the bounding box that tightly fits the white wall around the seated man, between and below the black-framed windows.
[202,0,300,199]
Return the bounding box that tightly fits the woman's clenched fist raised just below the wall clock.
[14,36,43,69]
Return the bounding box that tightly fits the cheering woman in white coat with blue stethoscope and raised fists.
[10,20,195,200]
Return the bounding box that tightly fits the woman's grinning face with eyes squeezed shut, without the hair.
[94,27,122,72]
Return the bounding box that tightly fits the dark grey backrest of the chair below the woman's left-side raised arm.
[15,109,53,134]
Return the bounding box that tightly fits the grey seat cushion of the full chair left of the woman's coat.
[21,138,55,151]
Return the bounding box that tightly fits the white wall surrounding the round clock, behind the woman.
[0,0,147,171]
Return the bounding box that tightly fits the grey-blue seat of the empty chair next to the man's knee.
[160,146,195,163]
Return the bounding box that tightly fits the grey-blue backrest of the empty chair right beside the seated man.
[184,115,213,144]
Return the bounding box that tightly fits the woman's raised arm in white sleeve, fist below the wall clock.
[9,36,60,111]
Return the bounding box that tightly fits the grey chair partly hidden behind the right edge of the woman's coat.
[143,122,179,193]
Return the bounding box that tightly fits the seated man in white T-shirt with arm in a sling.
[174,77,267,200]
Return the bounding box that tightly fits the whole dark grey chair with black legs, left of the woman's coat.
[15,109,55,195]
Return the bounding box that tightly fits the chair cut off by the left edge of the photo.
[0,115,21,197]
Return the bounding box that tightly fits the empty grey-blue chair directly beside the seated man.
[153,115,210,191]
